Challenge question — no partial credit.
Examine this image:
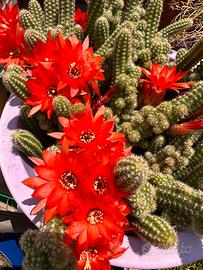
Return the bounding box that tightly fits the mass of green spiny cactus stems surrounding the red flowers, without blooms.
[3,0,203,264]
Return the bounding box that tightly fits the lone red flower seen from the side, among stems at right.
[139,63,191,106]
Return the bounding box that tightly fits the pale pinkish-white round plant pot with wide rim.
[0,97,203,269]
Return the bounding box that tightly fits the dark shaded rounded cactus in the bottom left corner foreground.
[20,230,76,270]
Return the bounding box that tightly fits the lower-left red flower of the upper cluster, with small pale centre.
[24,64,69,119]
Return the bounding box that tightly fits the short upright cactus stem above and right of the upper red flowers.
[94,16,110,50]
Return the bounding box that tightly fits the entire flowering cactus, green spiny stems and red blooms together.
[0,0,203,270]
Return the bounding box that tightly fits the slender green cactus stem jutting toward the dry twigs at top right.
[161,18,193,38]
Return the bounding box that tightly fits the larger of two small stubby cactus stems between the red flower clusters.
[53,96,71,118]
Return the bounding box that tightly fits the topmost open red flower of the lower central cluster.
[50,106,126,166]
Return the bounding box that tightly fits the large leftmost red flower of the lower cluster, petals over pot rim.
[23,150,84,221]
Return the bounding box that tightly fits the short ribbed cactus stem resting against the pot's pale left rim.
[12,129,43,158]
